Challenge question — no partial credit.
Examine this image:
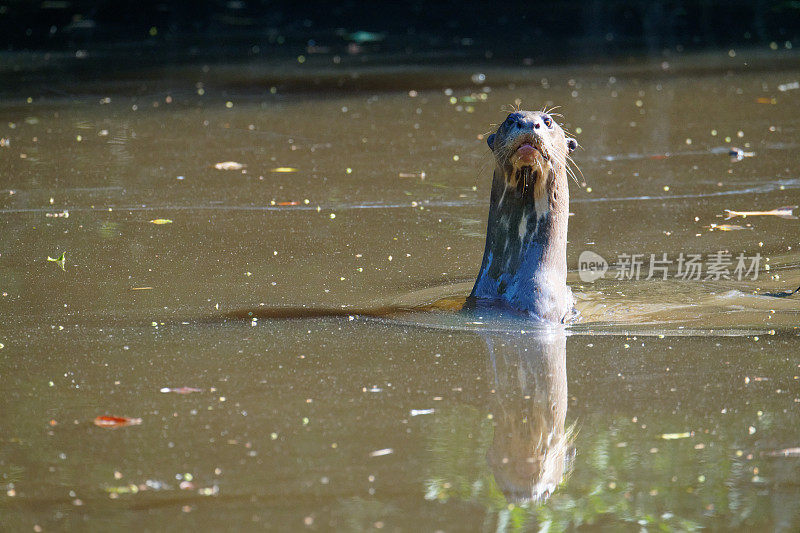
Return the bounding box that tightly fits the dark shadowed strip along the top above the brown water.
[0,0,800,62]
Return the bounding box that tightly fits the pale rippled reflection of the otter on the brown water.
[483,330,575,504]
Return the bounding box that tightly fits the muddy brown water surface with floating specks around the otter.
[0,48,800,531]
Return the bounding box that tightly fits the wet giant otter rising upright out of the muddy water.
[467,111,577,323]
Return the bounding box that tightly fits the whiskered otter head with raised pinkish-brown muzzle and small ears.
[487,111,578,214]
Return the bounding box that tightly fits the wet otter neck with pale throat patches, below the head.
[470,166,573,322]
